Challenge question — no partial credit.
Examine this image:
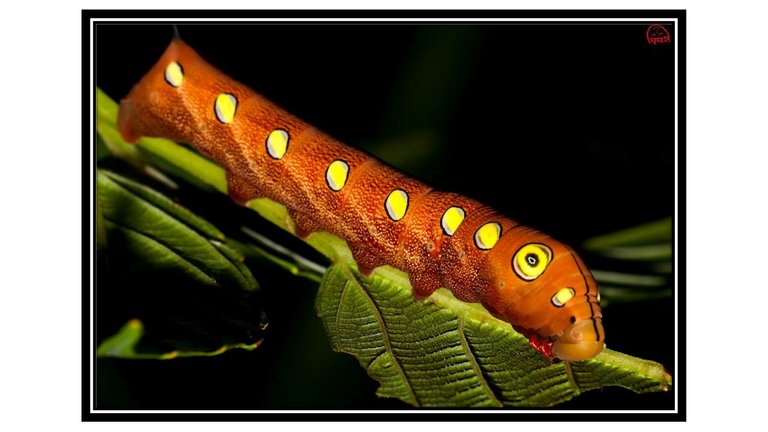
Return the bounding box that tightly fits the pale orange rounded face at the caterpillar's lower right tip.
[552,318,605,361]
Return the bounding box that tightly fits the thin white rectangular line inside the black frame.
[88,16,680,415]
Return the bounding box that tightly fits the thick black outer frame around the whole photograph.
[81,9,687,421]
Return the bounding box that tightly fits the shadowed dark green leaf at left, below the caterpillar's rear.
[97,170,266,359]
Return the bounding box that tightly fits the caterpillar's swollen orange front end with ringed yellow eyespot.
[483,227,605,361]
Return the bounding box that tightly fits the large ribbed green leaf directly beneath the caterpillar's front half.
[316,263,671,407]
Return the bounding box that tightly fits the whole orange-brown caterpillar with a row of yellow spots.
[118,36,605,361]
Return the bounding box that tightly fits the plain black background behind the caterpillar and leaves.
[95,23,675,409]
